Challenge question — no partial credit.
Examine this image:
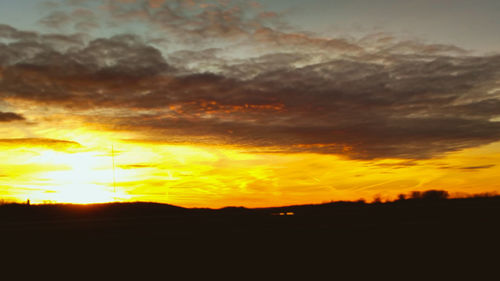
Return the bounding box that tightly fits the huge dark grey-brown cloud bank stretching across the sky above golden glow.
[0,23,500,159]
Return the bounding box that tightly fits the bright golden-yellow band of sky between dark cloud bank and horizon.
[0,123,500,207]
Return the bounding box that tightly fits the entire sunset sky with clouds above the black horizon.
[0,0,500,207]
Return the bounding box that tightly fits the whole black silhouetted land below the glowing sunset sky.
[0,191,500,274]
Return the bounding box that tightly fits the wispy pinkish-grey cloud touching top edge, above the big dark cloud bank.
[106,0,280,42]
